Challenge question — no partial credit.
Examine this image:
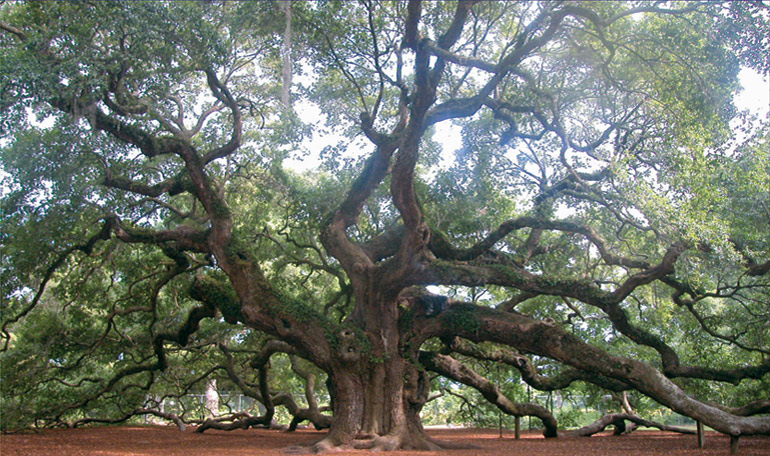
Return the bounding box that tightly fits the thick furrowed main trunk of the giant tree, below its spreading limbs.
[306,286,439,450]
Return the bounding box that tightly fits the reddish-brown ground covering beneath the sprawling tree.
[0,427,770,456]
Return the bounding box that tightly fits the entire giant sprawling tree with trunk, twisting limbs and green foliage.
[0,0,770,451]
